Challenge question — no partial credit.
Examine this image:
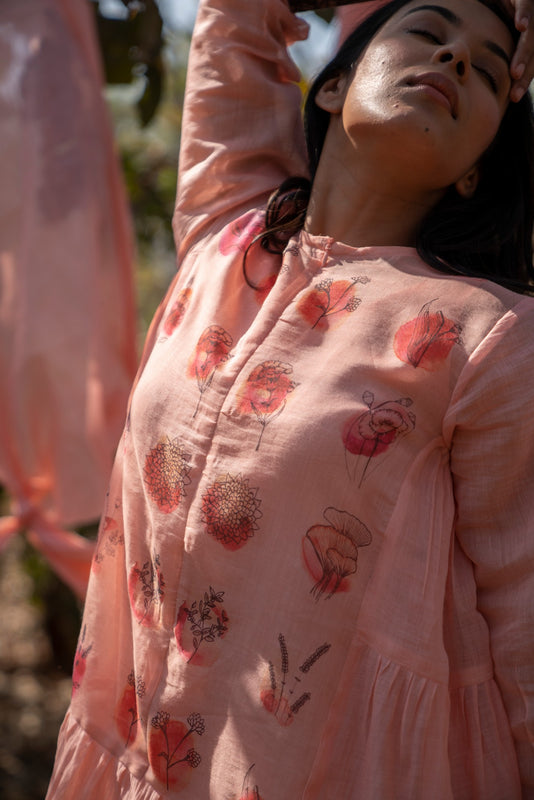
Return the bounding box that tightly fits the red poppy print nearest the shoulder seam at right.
[393,300,462,372]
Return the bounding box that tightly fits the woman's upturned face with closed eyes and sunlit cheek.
[330,0,514,191]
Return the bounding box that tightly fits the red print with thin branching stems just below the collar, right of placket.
[297,276,369,331]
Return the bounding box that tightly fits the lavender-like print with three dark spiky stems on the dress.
[260,633,331,727]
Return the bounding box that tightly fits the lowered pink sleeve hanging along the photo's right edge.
[448,299,534,798]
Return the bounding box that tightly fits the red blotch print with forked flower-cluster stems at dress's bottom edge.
[148,711,205,791]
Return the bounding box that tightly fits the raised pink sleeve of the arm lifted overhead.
[173,0,308,258]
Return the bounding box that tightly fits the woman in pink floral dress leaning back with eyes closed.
[48,0,534,800]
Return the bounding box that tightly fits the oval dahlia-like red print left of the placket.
[145,436,191,514]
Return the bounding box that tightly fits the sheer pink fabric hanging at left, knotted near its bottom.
[0,0,137,597]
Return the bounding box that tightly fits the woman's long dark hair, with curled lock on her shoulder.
[250,0,534,293]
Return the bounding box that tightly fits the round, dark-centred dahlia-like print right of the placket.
[202,475,262,550]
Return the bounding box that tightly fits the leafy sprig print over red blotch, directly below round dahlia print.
[174,586,229,666]
